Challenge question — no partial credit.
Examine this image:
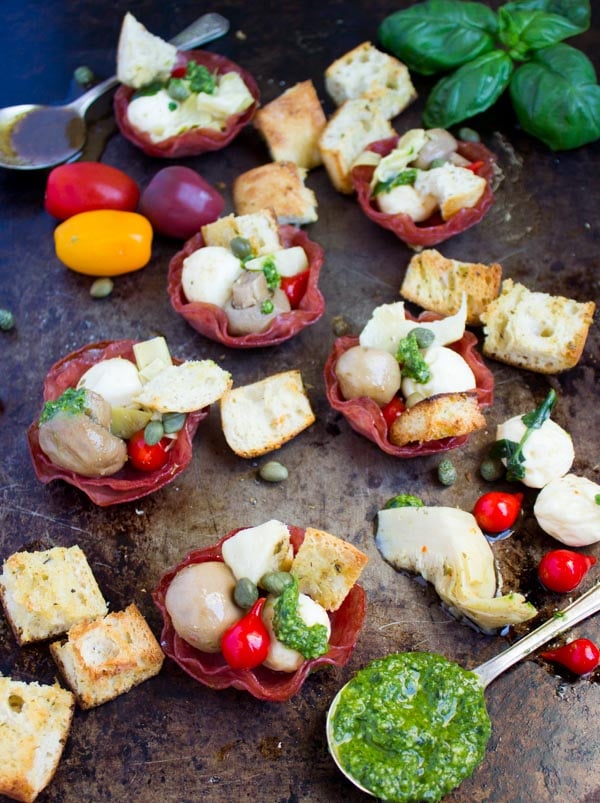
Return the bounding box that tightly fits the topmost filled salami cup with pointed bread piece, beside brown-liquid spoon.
[114,14,260,158]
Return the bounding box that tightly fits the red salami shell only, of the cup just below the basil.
[352,137,496,249]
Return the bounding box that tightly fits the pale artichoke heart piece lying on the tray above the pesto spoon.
[375,507,537,631]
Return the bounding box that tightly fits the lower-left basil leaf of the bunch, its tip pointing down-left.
[423,50,513,128]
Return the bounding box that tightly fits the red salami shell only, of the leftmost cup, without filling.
[27,340,208,507]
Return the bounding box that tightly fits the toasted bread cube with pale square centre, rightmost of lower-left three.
[50,603,164,708]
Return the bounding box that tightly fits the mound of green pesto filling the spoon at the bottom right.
[329,652,491,803]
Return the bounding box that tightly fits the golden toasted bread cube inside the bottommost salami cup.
[291,527,369,611]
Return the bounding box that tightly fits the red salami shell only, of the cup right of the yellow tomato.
[168,226,325,349]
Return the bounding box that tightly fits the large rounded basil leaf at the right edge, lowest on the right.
[510,43,600,151]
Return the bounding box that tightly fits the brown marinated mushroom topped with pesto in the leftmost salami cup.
[39,388,127,477]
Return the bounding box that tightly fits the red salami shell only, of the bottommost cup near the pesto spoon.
[152,525,366,702]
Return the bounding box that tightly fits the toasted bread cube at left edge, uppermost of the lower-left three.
[0,546,108,645]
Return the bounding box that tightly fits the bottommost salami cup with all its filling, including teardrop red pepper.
[153,519,368,702]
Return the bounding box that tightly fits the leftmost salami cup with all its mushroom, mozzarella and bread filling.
[27,337,232,507]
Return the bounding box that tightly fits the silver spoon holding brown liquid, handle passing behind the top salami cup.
[0,13,229,170]
